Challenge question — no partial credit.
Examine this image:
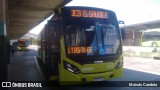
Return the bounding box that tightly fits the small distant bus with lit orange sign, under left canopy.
[17,39,29,51]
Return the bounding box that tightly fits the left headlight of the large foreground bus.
[64,61,80,74]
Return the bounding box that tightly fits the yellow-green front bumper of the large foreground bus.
[60,66,123,85]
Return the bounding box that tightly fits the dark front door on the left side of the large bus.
[46,21,61,80]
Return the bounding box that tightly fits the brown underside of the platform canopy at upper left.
[8,0,71,39]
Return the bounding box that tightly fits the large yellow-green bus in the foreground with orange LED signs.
[39,6,124,84]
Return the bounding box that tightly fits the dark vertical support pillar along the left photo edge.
[0,0,8,84]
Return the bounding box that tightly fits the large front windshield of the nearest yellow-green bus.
[63,8,122,56]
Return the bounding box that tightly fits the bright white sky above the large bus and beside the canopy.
[30,0,160,34]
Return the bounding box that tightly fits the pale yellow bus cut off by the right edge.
[141,28,160,47]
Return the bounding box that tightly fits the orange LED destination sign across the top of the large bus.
[71,10,108,18]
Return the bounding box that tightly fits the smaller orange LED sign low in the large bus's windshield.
[68,47,92,54]
